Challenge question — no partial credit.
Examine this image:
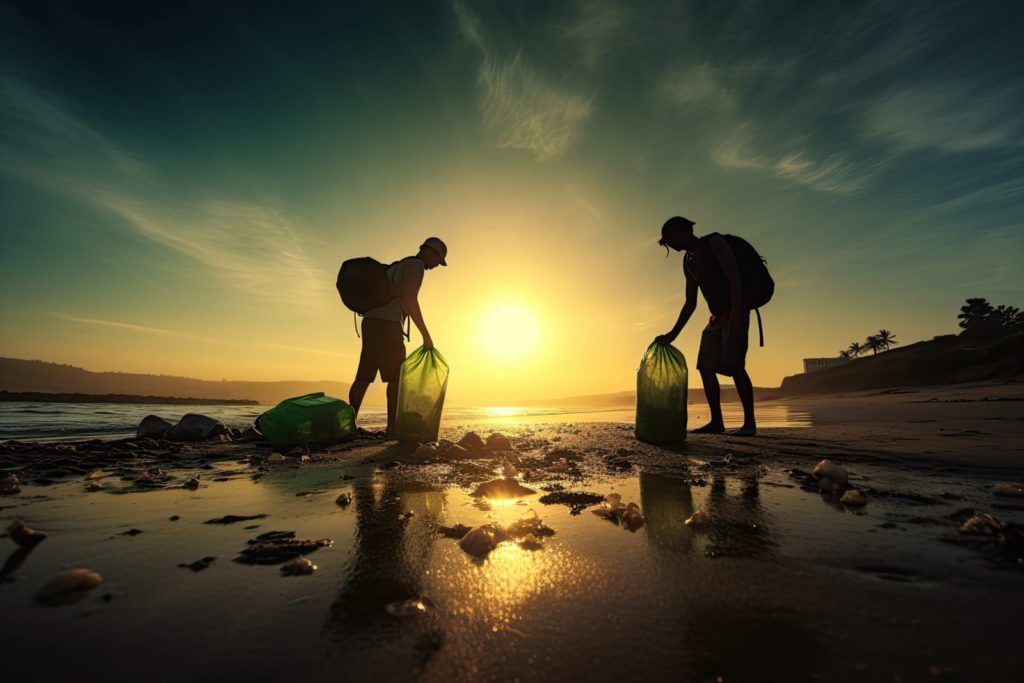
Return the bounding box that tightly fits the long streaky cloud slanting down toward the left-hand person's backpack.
[0,77,330,305]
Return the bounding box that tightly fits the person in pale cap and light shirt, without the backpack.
[348,238,447,435]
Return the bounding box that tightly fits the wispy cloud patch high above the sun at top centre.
[454,2,593,161]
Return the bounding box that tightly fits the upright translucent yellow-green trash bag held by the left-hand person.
[394,346,447,443]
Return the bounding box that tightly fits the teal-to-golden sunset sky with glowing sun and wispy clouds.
[0,0,1024,404]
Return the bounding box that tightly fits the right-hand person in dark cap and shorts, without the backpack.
[657,216,757,436]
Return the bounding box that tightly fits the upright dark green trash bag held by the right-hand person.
[636,342,687,443]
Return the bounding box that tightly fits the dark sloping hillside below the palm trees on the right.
[781,333,1024,396]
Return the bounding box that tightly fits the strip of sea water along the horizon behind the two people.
[0,402,810,440]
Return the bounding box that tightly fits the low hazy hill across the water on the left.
[0,357,349,403]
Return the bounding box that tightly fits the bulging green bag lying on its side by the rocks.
[256,391,355,449]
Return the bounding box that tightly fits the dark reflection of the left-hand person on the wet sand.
[325,475,443,655]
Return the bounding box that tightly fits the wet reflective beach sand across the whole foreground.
[0,384,1024,681]
